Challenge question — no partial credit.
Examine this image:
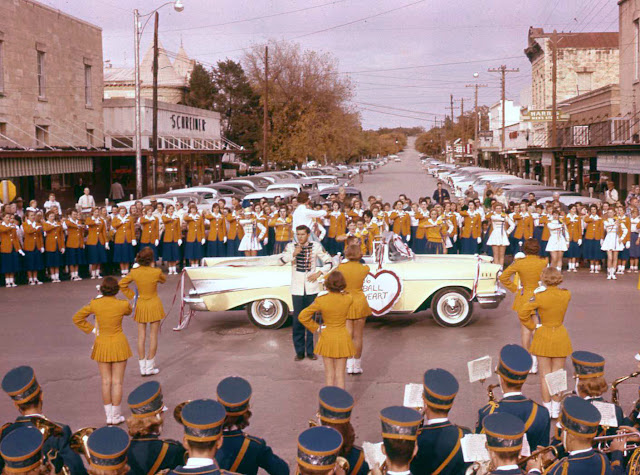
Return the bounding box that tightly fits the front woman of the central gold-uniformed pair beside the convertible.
[298,271,355,389]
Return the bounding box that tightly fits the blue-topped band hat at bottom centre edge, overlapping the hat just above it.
[296,426,343,475]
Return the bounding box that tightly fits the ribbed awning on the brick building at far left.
[0,157,93,178]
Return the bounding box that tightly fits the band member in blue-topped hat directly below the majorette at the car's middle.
[318,386,369,475]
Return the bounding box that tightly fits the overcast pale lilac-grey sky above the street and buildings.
[43,0,618,128]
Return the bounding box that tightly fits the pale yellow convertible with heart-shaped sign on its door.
[183,233,505,329]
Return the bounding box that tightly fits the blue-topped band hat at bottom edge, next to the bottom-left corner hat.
[86,427,132,475]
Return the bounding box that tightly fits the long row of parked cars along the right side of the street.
[422,157,600,206]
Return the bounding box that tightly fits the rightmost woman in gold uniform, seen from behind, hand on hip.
[518,267,573,417]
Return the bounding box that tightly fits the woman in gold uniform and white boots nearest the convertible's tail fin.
[119,247,167,376]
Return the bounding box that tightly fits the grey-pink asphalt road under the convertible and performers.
[0,139,640,470]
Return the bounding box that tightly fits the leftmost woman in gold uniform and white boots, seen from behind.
[73,277,132,424]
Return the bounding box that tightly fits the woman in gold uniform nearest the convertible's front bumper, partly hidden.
[500,242,547,374]
